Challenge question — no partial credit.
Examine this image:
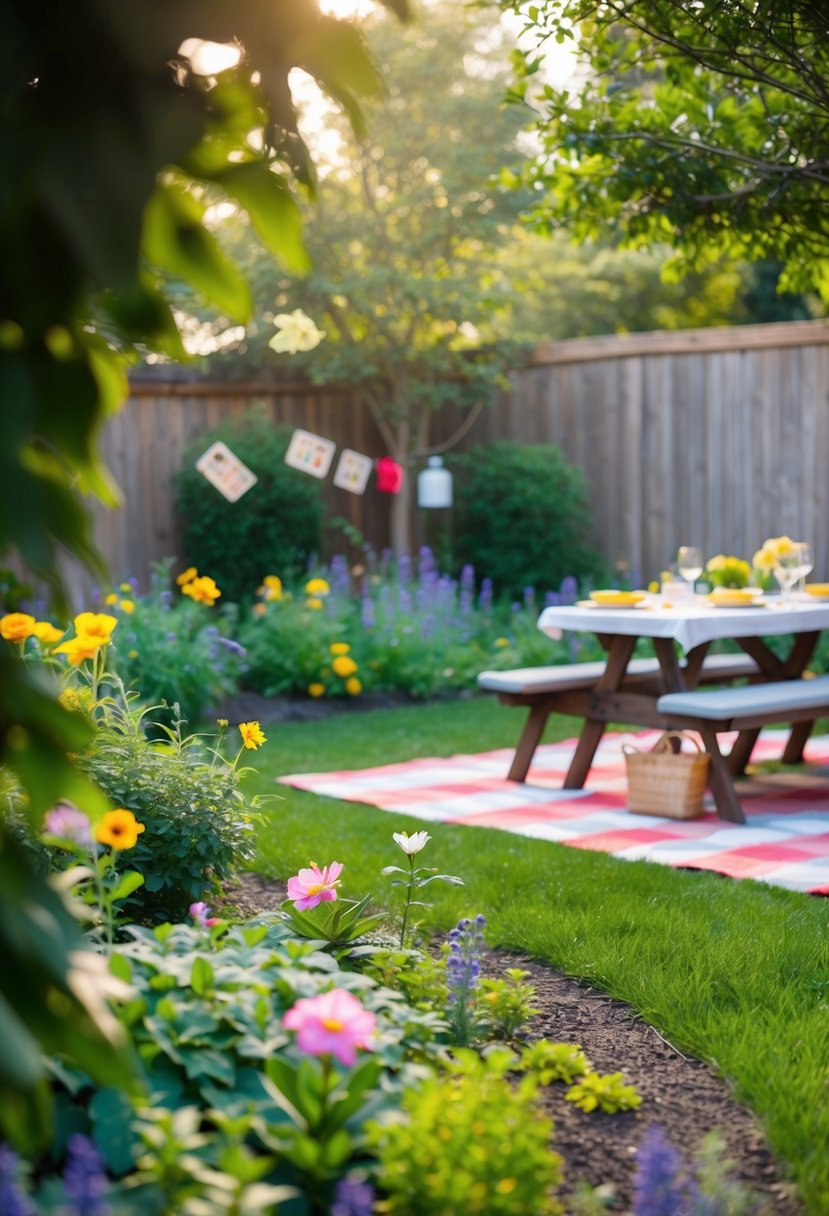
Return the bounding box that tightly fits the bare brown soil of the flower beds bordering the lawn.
[221,697,802,1216]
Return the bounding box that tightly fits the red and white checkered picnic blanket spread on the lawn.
[278,730,829,895]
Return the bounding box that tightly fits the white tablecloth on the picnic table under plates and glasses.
[538,597,829,651]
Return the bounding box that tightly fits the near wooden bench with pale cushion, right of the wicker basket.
[656,676,829,823]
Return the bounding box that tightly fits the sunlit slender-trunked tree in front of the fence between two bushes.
[182,4,529,552]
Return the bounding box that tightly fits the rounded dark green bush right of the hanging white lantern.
[451,443,604,596]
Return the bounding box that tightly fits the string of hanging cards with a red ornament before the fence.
[196,429,404,502]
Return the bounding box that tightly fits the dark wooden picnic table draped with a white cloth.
[528,596,829,822]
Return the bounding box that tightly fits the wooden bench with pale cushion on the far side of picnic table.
[478,653,760,781]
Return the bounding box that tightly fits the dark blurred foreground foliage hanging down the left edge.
[0,0,406,1143]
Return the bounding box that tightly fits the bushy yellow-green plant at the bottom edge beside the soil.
[367,1048,562,1216]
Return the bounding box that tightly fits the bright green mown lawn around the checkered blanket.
[240,698,829,1216]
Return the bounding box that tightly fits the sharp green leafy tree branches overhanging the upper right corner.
[503,0,829,302]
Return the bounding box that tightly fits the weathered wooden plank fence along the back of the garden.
[62,321,829,601]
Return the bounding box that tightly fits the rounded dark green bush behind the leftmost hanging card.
[176,410,322,602]
